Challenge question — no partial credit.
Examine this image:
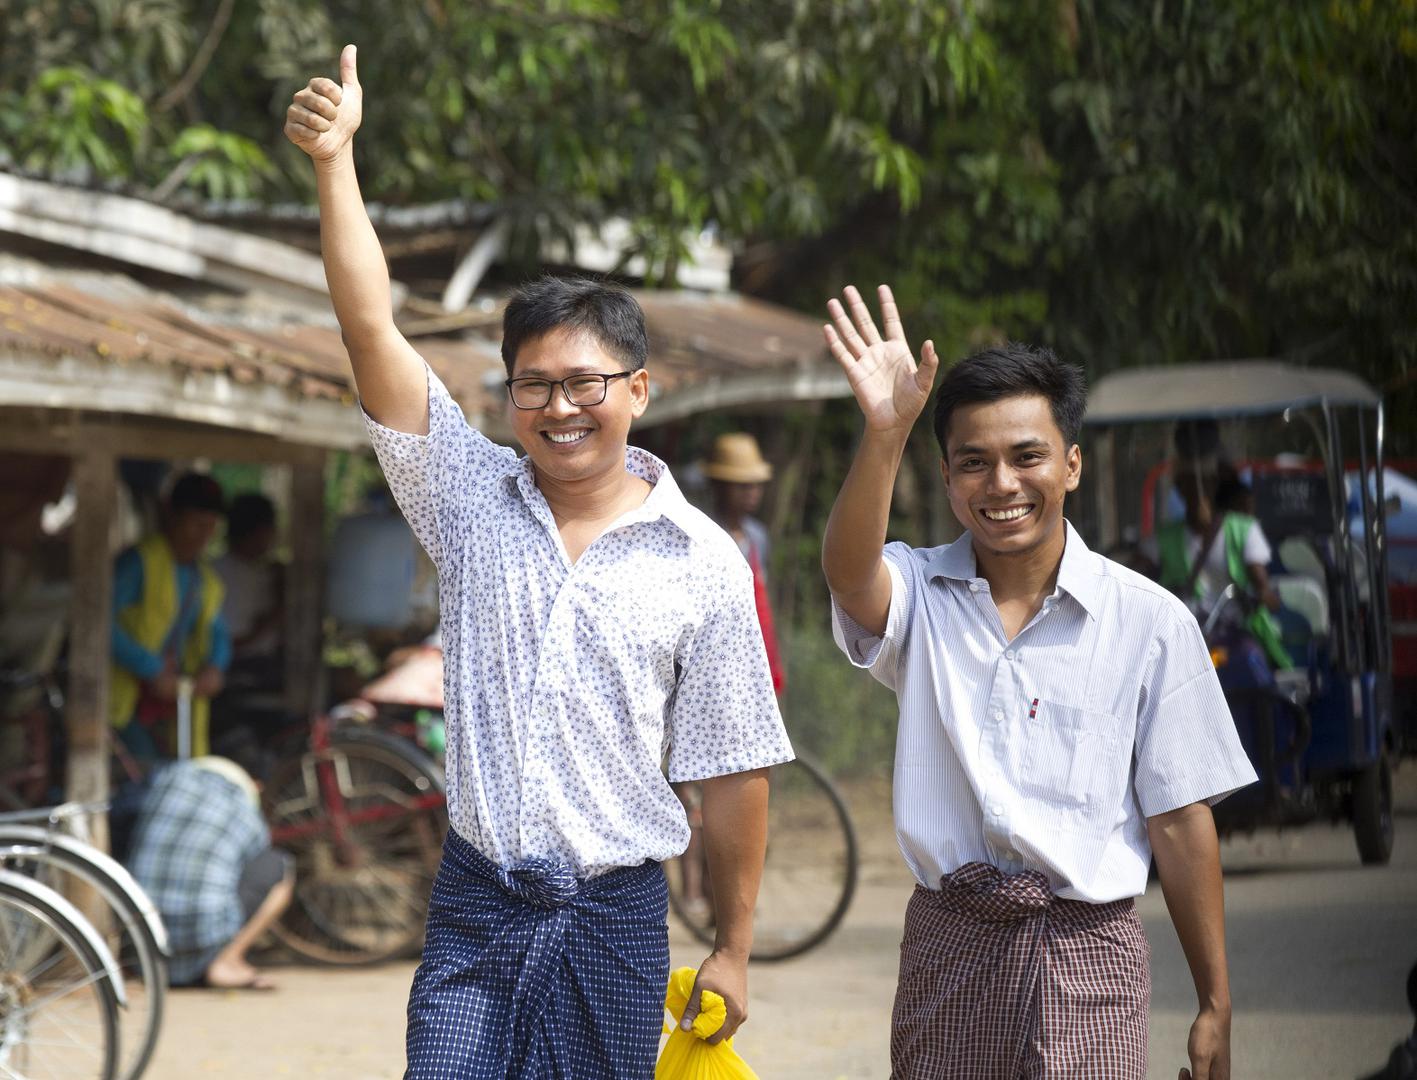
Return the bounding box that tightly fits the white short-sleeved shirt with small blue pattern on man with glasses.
[366,370,792,877]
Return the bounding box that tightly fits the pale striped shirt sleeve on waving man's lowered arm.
[1135,607,1257,818]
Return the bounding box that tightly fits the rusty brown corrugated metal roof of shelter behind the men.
[0,279,850,445]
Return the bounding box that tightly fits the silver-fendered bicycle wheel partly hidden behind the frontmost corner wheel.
[0,825,167,1080]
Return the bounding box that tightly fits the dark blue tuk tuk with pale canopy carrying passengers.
[1071,360,1403,863]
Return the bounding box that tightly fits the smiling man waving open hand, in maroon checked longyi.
[822,286,1255,1080]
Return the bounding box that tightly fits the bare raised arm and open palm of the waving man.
[822,285,939,635]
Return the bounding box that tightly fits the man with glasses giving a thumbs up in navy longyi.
[285,45,792,1080]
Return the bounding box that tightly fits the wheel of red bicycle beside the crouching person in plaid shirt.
[266,731,448,965]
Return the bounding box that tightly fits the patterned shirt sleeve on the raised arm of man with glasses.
[361,361,517,568]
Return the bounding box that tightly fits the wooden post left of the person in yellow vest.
[64,446,115,850]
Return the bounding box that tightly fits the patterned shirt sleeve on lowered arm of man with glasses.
[669,556,792,784]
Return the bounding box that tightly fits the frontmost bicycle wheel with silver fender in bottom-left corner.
[0,870,119,1080]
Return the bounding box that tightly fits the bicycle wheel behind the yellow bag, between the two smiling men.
[665,757,857,961]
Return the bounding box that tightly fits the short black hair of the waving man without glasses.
[935,342,1087,456]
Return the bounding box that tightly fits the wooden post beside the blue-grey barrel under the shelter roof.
[285,456,324,716]
